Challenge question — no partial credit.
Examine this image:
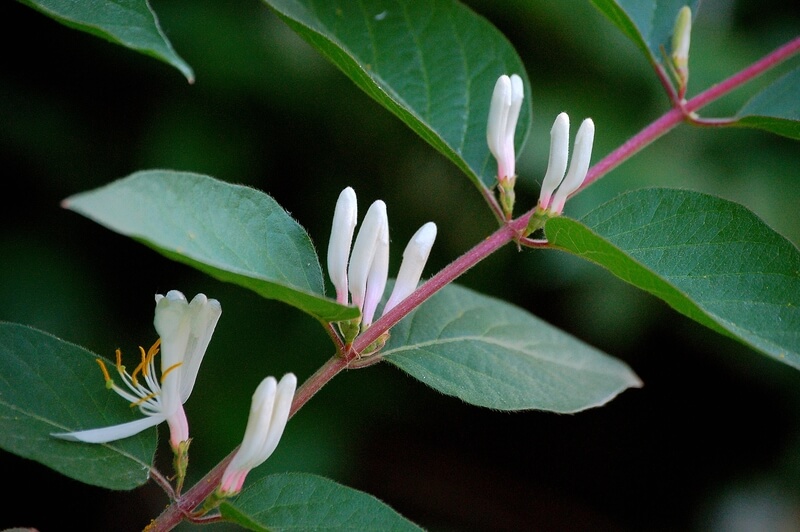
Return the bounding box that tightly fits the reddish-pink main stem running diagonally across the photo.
[147,37,800,532]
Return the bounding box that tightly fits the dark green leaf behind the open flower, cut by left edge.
[0,323,156,490]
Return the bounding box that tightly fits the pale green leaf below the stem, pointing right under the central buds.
[381,285,641,412]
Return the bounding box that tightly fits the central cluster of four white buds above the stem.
[328,187,436,342]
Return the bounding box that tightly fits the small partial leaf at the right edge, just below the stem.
[735,67,800,140]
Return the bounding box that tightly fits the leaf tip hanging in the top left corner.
[21,0,194,83]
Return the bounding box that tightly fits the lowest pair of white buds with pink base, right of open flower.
[219,373,297,497]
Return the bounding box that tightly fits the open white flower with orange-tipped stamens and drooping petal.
[52,290,222,451]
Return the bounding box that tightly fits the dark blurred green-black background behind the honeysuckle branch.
[0,0,800,531]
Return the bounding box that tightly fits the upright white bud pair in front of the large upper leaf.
[486,74,525,182]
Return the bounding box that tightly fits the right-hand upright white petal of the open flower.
[177,294,222,404]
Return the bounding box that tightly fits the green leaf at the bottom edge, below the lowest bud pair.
[220,473,421,531]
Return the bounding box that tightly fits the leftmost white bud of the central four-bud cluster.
[328,187,358,305]
